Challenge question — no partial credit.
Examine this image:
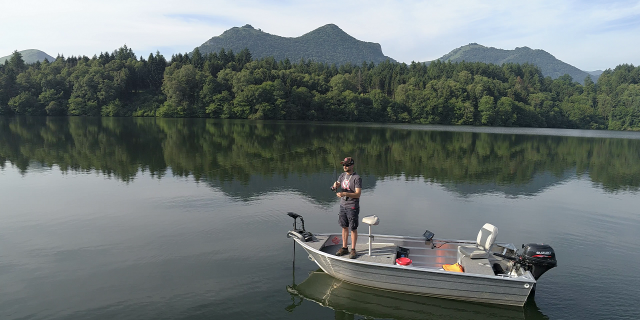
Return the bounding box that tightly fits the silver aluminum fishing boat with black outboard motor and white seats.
[287,212,557,306]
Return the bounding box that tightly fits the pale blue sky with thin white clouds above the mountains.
[0,0,640,71]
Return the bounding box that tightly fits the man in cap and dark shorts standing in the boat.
[331,157,362,259]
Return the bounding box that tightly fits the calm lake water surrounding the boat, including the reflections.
[0,117,640,319]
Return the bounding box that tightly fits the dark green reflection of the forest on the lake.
[0,117,640,191]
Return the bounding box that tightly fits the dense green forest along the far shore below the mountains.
[0,46,640,130]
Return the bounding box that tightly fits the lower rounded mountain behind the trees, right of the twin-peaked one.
[438,43,602,83]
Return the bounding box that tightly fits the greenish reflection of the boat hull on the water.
[287,270,548,319]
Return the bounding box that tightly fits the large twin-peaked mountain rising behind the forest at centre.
[198,24,395,65]
